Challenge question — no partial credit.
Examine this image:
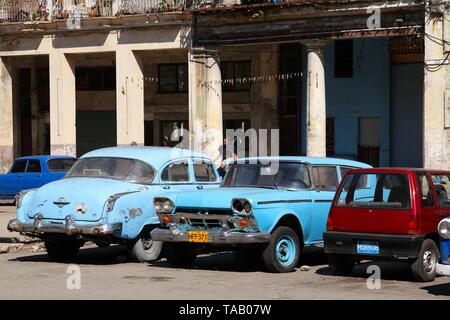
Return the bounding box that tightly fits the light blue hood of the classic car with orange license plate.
[166,187,299,209]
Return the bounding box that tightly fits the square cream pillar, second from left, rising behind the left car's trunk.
[50,51,76,156]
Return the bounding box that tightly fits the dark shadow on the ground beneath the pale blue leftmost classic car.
[9,245,127,265]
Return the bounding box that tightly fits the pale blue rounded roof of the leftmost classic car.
[81,146,209,169]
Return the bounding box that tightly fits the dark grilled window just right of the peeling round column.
[221,61,251,91]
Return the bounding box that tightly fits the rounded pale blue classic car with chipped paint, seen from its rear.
[8,147,220,261]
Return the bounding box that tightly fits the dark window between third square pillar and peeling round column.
[158,63,188,93]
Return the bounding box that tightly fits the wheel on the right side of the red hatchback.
[411,239,439,282]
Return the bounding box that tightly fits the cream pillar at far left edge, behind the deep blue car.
[0,57,14,173]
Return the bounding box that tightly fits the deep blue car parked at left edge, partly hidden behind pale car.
[0,156,77,200]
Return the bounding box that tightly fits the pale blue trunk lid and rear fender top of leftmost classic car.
[27,178,147,221]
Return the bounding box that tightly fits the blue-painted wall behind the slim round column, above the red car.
[302,38,390,165]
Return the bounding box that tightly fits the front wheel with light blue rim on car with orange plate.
[262,227,300,273]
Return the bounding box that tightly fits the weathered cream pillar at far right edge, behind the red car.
[423,8,450,169]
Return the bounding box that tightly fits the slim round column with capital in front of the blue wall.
[305,41,327,157]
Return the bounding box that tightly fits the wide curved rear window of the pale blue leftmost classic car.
[66,157,155,184]
